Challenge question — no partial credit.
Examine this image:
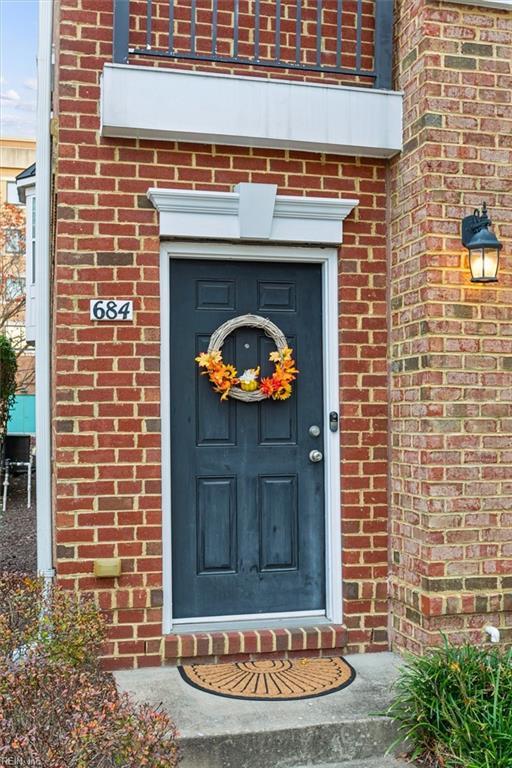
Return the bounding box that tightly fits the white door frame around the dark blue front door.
[160,242,342,634]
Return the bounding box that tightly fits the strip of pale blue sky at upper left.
[0,0,38,139]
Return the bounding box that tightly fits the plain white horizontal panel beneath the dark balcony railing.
[101,64,402,157]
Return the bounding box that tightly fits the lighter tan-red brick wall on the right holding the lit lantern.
[391,0,512,651]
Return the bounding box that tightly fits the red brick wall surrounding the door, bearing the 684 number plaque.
[53,0,387,666]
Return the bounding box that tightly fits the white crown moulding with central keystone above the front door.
[147,183,359,245]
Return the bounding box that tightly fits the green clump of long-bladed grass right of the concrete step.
[386,642,512,768]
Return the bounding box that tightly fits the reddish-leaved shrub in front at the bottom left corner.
[0,654,177,768]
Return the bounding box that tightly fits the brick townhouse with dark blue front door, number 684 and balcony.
[32,0,512,667]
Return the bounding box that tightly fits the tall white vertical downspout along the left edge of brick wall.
[35,0,54,578]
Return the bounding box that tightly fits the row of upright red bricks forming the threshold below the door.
[164,624,347,665]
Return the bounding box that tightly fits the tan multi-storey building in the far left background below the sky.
[0,138,36,397]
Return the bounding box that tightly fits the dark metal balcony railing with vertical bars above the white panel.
[113,0,393,89]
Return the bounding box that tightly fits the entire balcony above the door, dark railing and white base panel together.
[102,0,402,157]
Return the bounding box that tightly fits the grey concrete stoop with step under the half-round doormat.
[116,653,404,768]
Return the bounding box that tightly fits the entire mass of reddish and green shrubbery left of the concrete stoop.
[0,574,178,768]
